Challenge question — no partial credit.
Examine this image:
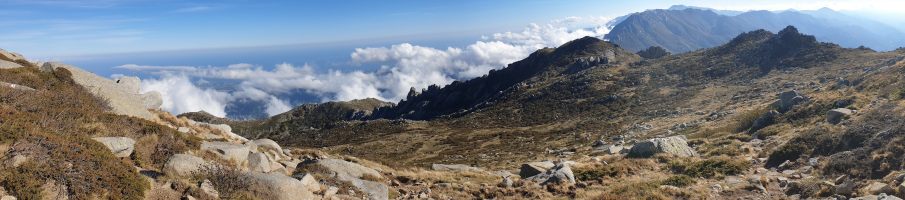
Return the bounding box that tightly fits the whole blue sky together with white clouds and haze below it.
[0,0,905,116]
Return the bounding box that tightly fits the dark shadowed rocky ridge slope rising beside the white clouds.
[372,37,637,119]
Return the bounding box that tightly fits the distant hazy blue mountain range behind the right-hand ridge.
[605,5,905,53]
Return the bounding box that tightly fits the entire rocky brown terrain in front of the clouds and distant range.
[7,27,905,200]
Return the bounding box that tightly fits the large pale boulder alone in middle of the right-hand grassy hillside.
[628,136,698,157]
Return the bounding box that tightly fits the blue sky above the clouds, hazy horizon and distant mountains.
[0,0,905,58]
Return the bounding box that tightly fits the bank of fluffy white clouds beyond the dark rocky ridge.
[116,17,610,117]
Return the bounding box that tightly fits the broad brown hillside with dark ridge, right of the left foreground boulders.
[178,27,905,199]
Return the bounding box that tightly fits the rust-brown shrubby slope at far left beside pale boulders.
[0,68,198,199]
